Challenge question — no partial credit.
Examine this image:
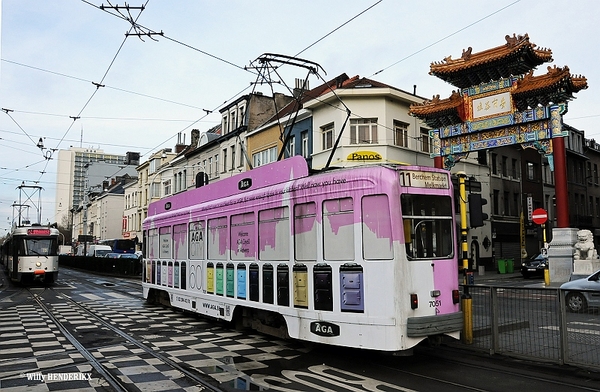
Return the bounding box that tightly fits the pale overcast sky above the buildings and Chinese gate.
[0,0,600,228]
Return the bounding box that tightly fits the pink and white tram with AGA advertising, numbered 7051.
[143,157,463,351]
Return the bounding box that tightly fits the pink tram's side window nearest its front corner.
[362,195,394,260]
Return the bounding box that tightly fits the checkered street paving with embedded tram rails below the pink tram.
[0,268,600,392]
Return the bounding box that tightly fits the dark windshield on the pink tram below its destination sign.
[401,194,454,260]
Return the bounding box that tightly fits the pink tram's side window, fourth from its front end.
[258,207,290,261]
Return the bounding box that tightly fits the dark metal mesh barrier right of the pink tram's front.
[463,285,600,370]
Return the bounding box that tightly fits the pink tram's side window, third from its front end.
[294,202,317,261]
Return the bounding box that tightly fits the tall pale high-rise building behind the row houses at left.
[55,147,140,227]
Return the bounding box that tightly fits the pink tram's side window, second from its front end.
[323,197,354,260]
